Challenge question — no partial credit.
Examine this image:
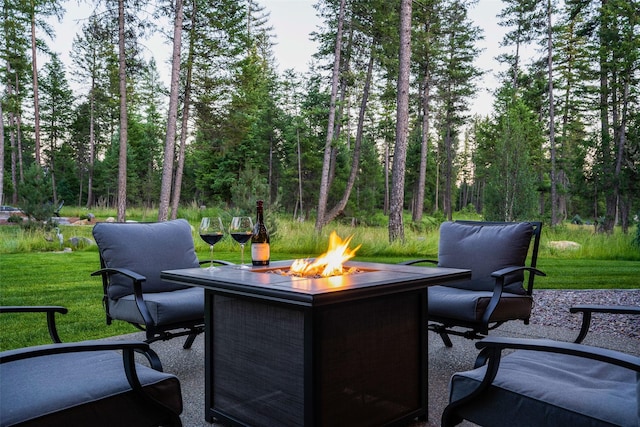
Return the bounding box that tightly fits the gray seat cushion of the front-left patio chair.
[0,351,182,427]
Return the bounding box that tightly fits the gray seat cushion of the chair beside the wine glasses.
[109,288,204,326]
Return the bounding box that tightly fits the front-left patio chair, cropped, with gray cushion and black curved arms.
[0,306,182,427]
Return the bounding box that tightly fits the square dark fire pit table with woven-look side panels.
[162,261,471,427]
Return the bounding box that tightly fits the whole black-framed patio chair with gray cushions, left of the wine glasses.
[92,219,230,349]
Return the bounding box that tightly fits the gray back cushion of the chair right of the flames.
[438,222,533,294]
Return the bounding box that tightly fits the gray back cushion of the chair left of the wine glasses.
[93,219,199,299]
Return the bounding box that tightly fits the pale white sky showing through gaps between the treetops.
[51,0,532,115]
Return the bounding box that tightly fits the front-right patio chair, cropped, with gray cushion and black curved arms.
[442,306,640,427]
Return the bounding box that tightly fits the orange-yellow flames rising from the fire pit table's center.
[289,231,362,277]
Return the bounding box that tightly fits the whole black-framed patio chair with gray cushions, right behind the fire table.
[402,221,545,347]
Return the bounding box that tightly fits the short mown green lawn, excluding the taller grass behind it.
[0,251,640,350]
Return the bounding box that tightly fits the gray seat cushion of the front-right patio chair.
[450,350,639,427]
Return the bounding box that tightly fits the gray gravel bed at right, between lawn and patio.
[531,289,640,339]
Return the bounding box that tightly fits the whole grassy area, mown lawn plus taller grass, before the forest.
[0,213,640,350]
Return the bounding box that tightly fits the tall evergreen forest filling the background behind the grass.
[0,0,640,240]
